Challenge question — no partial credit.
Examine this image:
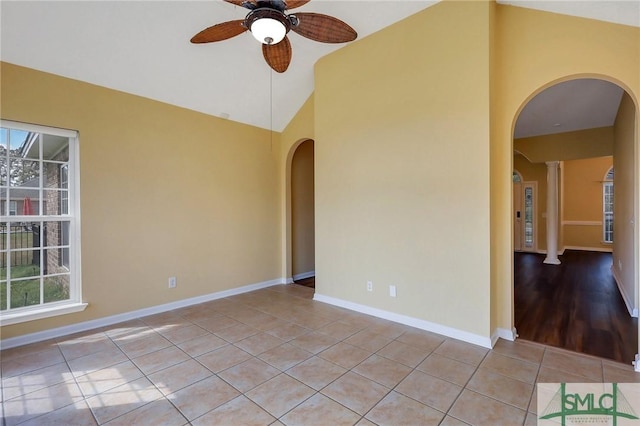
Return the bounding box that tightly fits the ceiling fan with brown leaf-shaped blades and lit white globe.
[191,0,358,73]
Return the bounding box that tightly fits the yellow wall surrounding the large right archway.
[491,5,640,336]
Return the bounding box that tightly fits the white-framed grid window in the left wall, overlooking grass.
[0,121,86,325]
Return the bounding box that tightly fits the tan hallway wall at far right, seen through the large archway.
[613,94,640,315]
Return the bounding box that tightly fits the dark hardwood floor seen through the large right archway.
[514,250,638,364]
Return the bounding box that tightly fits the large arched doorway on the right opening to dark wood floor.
[513,78,638,363]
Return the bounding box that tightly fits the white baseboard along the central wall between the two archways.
[313,292,492,349]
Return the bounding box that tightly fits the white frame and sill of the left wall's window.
[0,120,88,326]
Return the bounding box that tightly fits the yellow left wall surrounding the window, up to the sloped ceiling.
[0,63,281,339]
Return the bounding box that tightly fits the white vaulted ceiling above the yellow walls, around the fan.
[0,0,640,135]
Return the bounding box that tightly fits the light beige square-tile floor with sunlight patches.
[0,285,640,426]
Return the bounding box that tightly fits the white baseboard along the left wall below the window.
[0,278,286,349]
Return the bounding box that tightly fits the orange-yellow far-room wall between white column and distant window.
[561,156,613,251]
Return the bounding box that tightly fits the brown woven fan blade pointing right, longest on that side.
[291,13,358,43]
